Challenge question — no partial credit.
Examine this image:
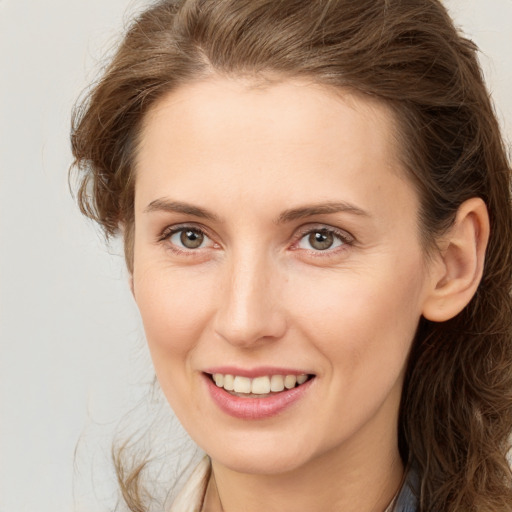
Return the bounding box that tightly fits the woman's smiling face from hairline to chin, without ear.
[133,78,429,473]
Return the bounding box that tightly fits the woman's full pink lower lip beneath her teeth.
[204,375,314,420]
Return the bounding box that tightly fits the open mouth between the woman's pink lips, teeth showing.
[205,373,315,398]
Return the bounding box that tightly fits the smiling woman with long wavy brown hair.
[72,0,512,512]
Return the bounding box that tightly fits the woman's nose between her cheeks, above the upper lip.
[215,251,286,348]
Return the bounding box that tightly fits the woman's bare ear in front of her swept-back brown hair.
[422,197,489,322]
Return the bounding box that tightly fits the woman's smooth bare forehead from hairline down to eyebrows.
[136,78,411,222]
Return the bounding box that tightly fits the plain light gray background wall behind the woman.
[0,0,512,512]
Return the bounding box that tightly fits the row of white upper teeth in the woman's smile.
[213,373,308,395]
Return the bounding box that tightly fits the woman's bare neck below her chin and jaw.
[203,428,404,512]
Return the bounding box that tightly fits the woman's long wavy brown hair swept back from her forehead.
[72,0,512,512]
